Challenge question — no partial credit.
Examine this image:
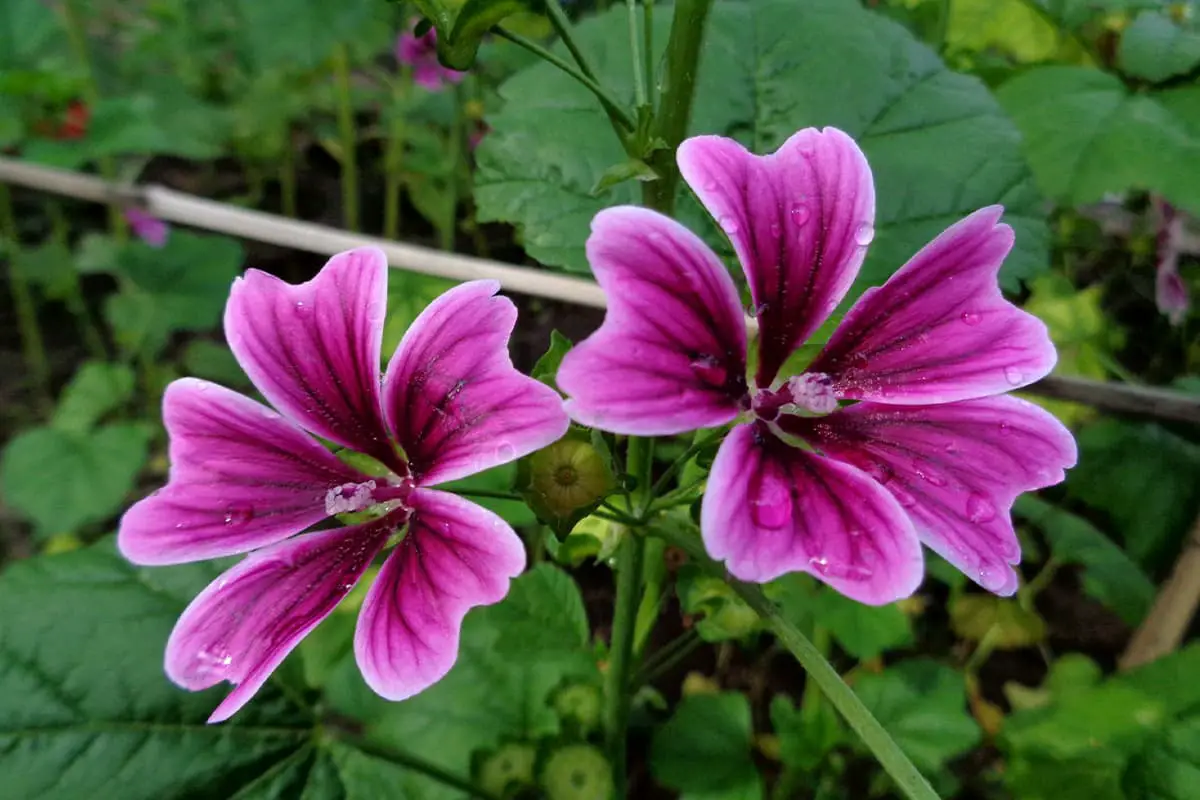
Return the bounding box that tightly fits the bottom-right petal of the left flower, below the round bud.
[354,489,526,700]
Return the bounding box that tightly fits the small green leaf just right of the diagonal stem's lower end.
[854,658,980,774]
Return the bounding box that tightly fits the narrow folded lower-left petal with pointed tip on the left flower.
[166,516,388,722]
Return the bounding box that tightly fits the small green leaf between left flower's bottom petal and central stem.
[492,564,590,658]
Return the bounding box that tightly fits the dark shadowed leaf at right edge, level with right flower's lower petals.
[1067,420,1200,573]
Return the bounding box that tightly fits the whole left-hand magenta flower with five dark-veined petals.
[118,248,569,722]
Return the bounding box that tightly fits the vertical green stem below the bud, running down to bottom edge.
[605,534,646,800]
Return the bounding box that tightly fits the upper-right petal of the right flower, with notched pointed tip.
[809,205,1056,405]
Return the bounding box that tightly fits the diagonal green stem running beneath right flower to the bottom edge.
[650,528,937,800]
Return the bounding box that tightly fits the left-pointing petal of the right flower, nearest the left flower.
[558,206,746,435]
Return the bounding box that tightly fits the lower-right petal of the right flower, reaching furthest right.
[785,397,1076,595]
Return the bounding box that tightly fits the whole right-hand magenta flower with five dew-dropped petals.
[558,128,1075,603]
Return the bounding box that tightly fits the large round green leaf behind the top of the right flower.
[475,0,1048,290]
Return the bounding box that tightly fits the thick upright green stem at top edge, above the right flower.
[642,0,713,216]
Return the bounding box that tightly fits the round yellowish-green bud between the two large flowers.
[517,433,613,535]
